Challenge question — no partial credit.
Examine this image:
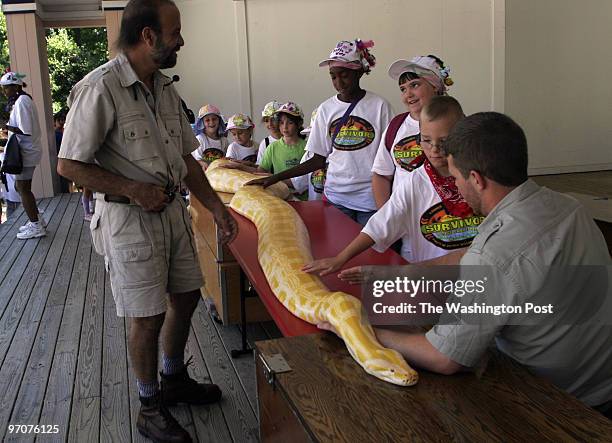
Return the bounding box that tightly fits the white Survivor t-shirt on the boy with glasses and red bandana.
[361,166,484,263]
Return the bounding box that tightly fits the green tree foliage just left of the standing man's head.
[47,28,108,112]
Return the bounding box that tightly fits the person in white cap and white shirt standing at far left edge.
[0,72,47,240]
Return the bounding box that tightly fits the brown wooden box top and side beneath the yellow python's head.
[256,334,612,443]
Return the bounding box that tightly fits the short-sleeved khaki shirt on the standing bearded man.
[58,53,199,189]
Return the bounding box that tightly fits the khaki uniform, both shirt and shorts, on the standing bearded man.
[59,54,203,317]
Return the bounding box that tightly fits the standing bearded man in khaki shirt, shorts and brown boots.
[58,0,237,442]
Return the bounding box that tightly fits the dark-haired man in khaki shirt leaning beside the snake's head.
[320,112,612,416]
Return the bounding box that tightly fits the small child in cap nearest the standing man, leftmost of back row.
[191,105,229,170]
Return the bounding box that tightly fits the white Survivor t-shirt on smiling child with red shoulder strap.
[372,115,423,191]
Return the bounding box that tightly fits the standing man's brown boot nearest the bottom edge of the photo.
[136,394,192,443]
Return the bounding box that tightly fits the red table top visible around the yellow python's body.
[229,201,406,337]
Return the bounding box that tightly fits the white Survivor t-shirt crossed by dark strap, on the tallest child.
[306,92,393,212]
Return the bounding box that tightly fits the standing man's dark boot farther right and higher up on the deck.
[161,357,221,406]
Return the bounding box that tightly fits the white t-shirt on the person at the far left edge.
[7,94,42,167]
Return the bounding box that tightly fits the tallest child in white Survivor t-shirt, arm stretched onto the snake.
[250,40,393,226]
